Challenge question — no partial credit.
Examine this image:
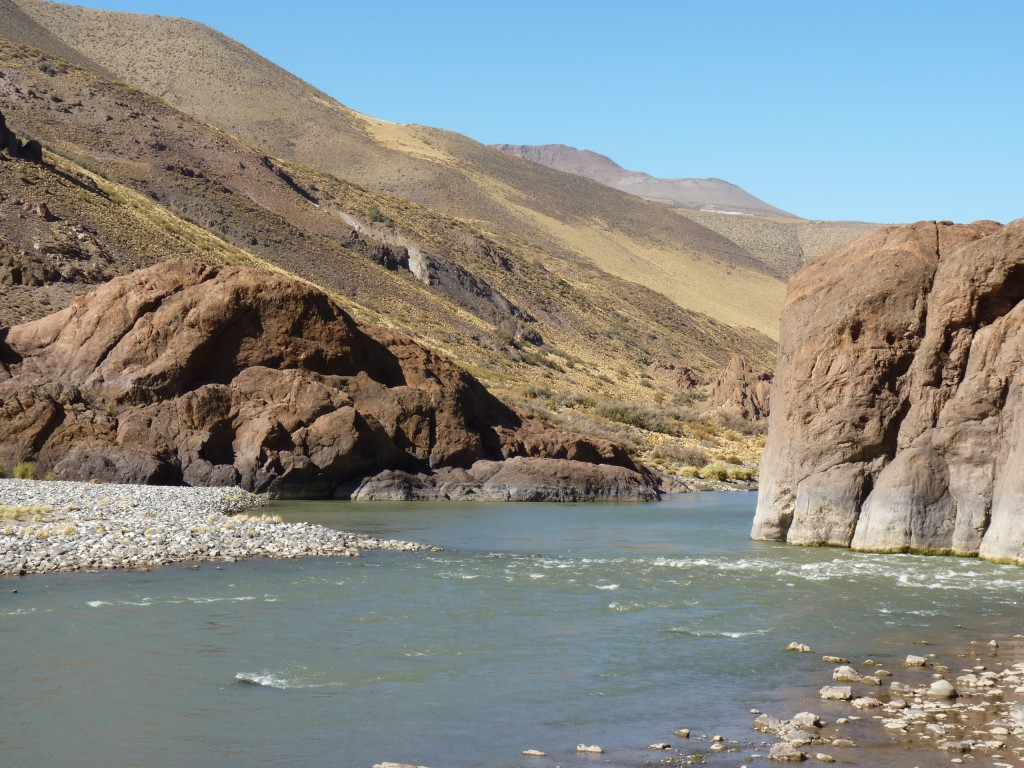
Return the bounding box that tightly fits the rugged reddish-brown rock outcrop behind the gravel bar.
[0,261,656,499]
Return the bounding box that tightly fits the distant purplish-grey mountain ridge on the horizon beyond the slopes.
[492,144,800,218]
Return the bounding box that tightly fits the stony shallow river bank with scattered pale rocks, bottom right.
[737,634,1024,768]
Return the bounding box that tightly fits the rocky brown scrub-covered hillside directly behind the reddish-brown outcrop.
[0,34,774,444]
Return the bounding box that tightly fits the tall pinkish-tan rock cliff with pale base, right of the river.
[753,219,1024,564]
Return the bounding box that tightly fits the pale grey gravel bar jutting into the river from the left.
[0,478,436,575]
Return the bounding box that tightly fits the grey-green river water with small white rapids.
[0,494,1024,768]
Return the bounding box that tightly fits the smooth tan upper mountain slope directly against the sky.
[12,0,784,338]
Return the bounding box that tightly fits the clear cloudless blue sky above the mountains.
[66,0,1024,222]
